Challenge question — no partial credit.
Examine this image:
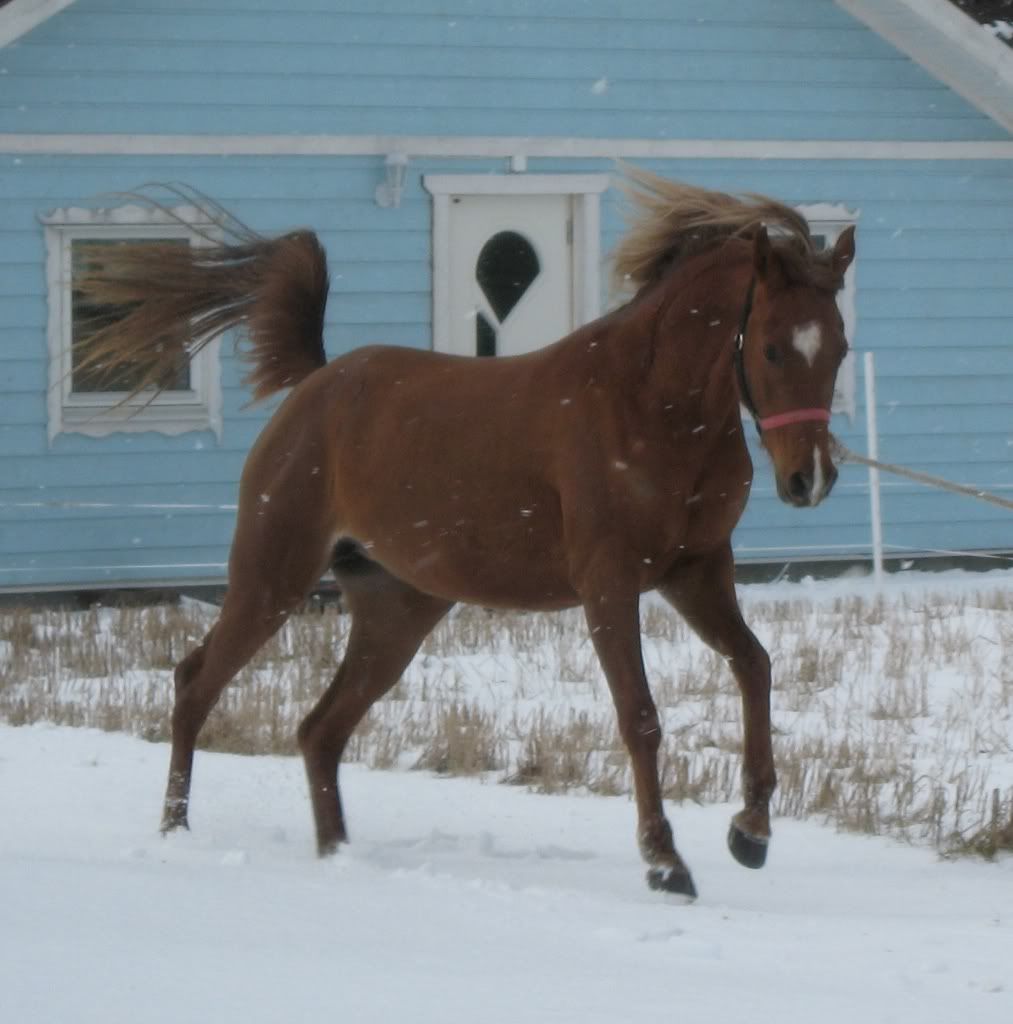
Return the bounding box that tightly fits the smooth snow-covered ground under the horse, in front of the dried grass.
[0,726,1013,1024]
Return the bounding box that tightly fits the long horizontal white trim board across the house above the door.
[0,135,1013,165]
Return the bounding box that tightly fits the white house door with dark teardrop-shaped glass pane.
[448,195,576,355]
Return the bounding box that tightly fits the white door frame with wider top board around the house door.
[422,174,609,352]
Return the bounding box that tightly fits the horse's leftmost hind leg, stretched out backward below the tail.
[162,520,330,833]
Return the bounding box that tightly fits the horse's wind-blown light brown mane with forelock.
[611,164,841,291]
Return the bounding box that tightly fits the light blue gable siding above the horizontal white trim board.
[0,0,1005,139]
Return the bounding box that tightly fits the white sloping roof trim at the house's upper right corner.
[836,0,1013,132]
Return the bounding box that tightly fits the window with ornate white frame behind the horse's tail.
[43,206,221,443]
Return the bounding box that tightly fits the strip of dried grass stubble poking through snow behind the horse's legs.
[0,591,1013,857]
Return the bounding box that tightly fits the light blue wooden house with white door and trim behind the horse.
[0,0,1013,591]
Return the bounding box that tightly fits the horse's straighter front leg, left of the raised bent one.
[579,557,697,899]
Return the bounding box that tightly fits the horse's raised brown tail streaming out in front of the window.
[74,222,330,400]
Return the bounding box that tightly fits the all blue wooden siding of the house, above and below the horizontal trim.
[0,0,1013,588]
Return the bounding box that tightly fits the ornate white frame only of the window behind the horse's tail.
[41,205,222,444]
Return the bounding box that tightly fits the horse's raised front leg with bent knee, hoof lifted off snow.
[658,546,777,867]
